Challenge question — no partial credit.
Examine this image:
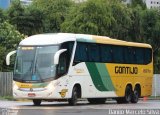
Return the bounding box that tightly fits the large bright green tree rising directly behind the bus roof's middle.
[61,0,131,40]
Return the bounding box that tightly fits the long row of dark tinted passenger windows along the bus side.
[74,42,152,64]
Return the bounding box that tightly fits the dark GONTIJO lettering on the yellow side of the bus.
[115,66,138,74]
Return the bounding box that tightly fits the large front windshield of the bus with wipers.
[13,45,59,82]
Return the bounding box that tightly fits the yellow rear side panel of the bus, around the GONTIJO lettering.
[106,64,153,97]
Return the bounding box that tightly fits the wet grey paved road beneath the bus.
[0,100,160,115]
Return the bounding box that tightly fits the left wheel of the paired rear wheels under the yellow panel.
[124,86,133,103]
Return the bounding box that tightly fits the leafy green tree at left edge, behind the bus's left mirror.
[0,21,24,71]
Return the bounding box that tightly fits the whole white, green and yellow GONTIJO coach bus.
[6,33,153,106]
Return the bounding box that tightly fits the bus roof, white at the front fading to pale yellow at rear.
[19,33,151,48]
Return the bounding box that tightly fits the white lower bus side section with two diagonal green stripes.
[69,62,117,98]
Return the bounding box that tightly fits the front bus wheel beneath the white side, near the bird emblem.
[68,87,78,106]
